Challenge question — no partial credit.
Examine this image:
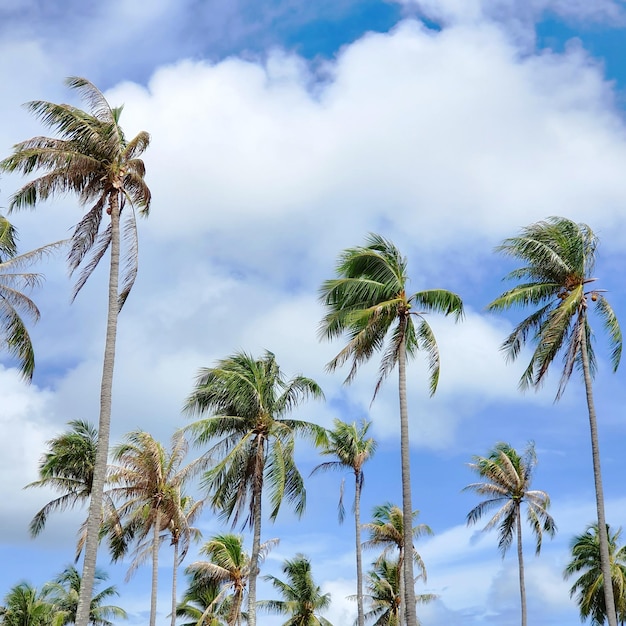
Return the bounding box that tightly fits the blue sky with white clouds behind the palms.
[0,0,626,626]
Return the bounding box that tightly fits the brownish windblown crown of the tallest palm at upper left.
[0,77,151,308]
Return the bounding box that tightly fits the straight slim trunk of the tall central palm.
[398,332,418,626]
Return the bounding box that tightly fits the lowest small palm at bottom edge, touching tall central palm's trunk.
[358,558,438,626]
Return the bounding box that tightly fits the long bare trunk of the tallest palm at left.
[76,193,120,626]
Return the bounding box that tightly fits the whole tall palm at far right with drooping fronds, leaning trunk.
[488,217,622,626]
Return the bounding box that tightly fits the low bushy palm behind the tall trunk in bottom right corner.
[563,524,626,626]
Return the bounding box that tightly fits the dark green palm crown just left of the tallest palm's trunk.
[25,420,98,537]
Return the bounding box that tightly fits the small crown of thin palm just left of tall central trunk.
[311,418,377,522]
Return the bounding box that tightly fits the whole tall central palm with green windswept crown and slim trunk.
[320,234,463,626]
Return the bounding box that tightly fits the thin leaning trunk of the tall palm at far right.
[580,328,617,626]
